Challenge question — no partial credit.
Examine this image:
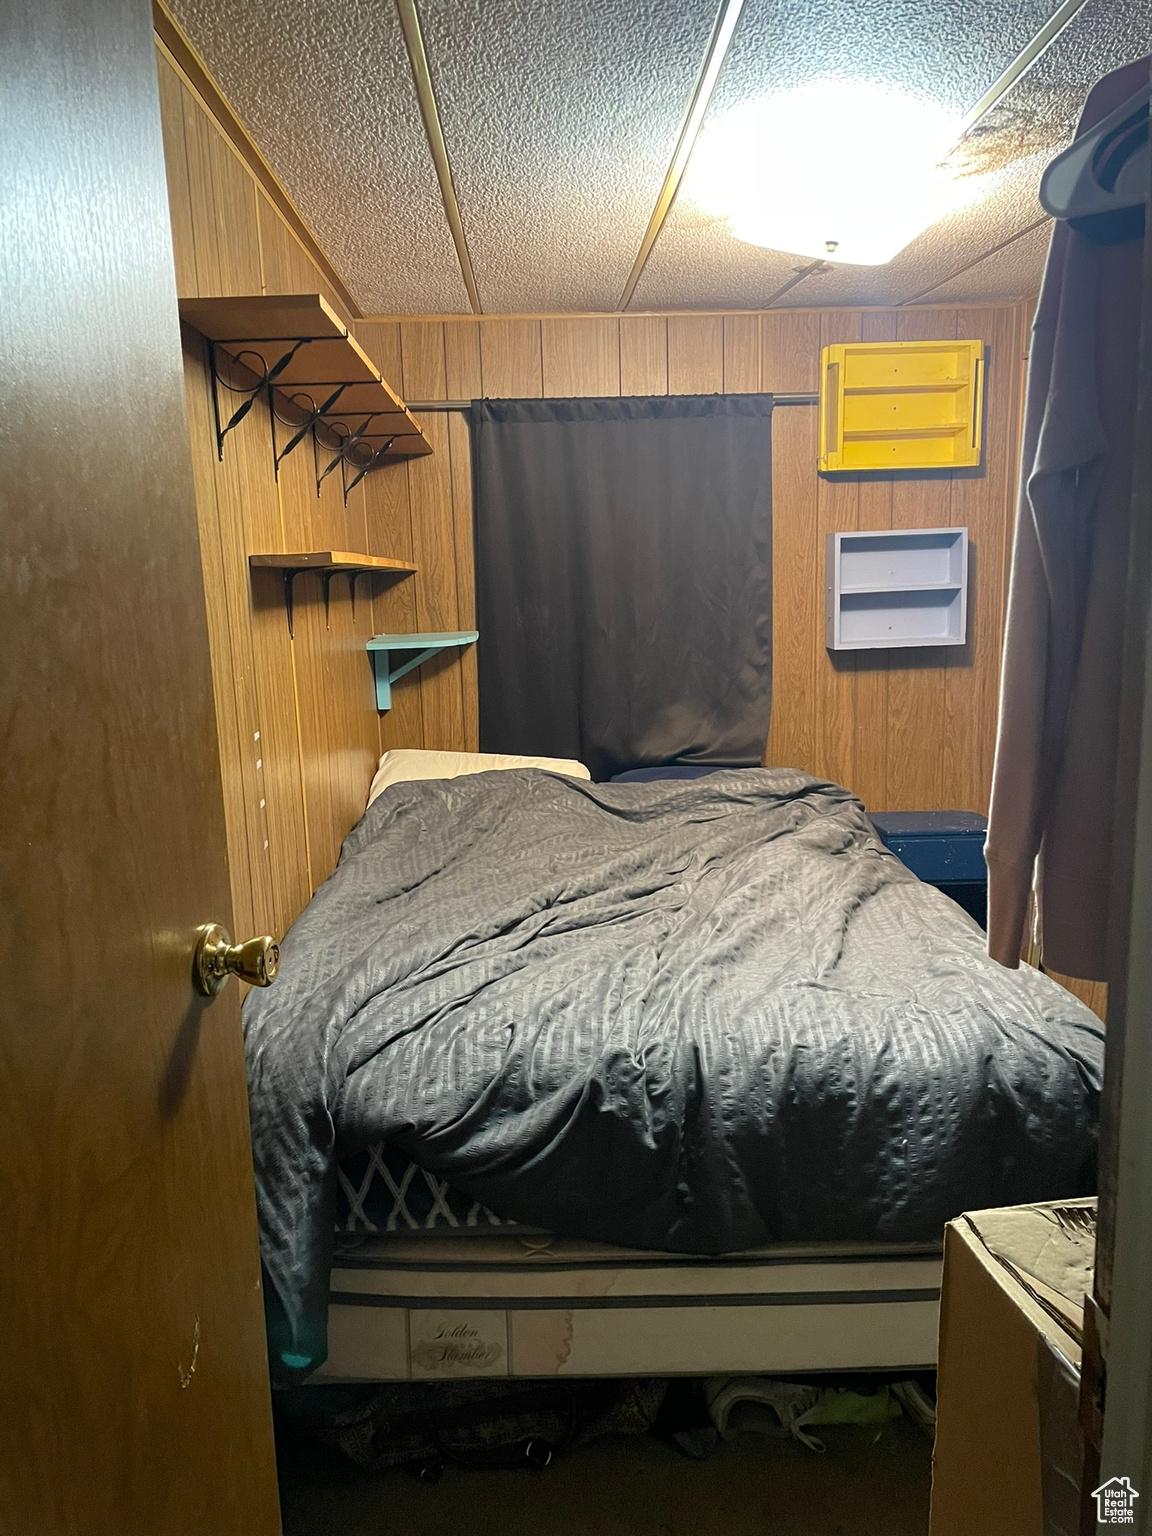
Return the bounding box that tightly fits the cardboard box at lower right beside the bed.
[929,1201,1095,1536]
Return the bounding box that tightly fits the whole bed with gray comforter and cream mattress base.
[246,752,1103,1379]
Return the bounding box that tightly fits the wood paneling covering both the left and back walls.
[158,29,1025,952]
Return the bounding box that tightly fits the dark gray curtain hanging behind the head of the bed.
[472,395,773,779]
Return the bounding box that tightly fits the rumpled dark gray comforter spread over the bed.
[244,770,1103,1370]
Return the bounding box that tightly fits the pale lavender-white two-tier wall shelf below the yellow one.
[825,528,968,651]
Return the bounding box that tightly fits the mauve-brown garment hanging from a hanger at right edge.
[986,58,1149,980]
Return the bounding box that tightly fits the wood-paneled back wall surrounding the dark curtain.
[355,306,1025,811]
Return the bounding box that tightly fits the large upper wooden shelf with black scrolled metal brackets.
[180,293,432,501]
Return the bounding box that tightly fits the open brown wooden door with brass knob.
[0,0,280,1536]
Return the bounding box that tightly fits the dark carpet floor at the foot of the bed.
[280,1419,932,1536]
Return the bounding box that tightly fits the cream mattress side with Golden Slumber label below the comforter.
[312,1227,942,1382]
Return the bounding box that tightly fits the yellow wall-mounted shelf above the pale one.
[820,341,985,473]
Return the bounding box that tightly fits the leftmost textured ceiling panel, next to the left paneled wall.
[170,0,468,315]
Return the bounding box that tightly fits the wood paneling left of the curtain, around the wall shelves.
[158,46,476,935]
